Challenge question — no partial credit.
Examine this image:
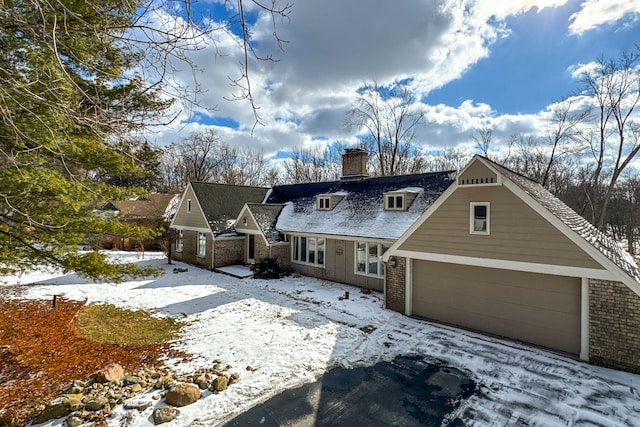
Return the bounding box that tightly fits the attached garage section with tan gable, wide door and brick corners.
[382,156,640,372]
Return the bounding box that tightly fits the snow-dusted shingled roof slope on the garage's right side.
[478,156,640,283]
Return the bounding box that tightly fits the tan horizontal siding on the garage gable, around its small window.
[399,186,602,269]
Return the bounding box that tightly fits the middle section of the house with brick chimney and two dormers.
[236,149,453,291]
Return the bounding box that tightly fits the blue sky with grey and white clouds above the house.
[152,0,640,164]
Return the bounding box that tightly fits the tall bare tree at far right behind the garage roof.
[581,51,640,229]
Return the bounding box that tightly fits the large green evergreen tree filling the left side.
[0,0,175,280]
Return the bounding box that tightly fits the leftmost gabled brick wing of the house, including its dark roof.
[171,182,267,269]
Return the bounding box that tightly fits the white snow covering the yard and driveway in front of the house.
[0,252,640,427]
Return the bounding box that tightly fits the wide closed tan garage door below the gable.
[412,260,581,354]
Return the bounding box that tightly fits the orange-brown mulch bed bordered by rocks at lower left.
[0,288,185,426]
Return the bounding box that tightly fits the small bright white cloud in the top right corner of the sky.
[569,0,640,35]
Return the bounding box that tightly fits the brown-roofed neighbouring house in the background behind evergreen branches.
[97,193,180,250]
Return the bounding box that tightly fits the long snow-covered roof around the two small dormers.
[266,172,454,240]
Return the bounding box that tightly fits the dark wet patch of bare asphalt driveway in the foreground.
[225,356,476,427]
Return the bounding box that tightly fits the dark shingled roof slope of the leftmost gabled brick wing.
[191,182,268,234]
